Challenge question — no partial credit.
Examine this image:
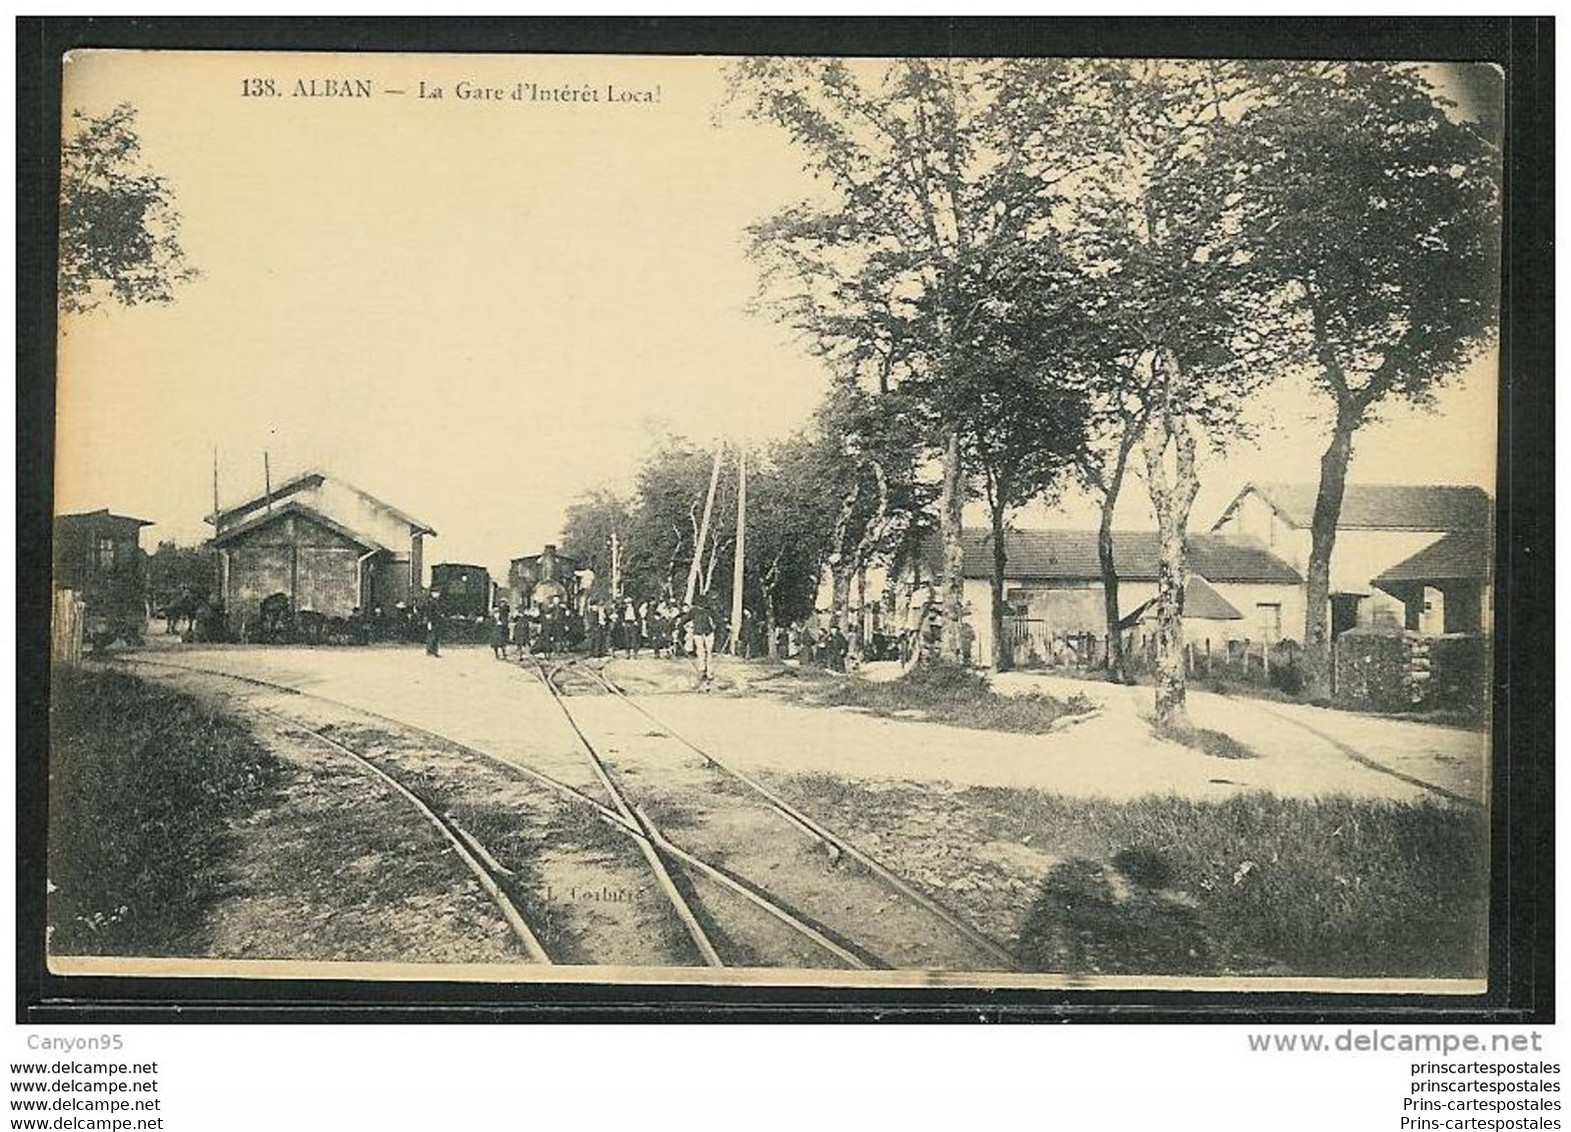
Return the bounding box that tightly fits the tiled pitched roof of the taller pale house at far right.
[1211,484,1489,531]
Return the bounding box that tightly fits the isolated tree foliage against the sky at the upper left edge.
[60,102,196,312]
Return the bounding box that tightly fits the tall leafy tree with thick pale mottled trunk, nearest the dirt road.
[1076,61,1280,727]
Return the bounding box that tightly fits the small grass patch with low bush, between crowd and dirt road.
[763,666,1090,735]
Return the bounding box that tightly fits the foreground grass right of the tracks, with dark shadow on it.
[792,776,1489,978]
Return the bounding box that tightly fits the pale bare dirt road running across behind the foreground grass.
[128,647,1488,801]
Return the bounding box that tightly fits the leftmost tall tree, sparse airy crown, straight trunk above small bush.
[732,58,1078,661]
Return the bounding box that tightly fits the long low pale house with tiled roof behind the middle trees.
[916,528,1304,663]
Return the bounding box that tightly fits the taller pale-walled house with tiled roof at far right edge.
[1211,484,1492,636]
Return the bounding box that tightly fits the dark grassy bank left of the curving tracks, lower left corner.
[49,670,280,955]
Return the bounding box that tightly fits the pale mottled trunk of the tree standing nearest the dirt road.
[1145,350,1200,728]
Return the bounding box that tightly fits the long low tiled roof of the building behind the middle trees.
[930,528,1304,586]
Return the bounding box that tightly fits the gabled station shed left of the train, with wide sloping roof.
[207,471,435,625]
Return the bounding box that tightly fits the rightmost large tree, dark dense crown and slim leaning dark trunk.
[1240,63,1500,697]
